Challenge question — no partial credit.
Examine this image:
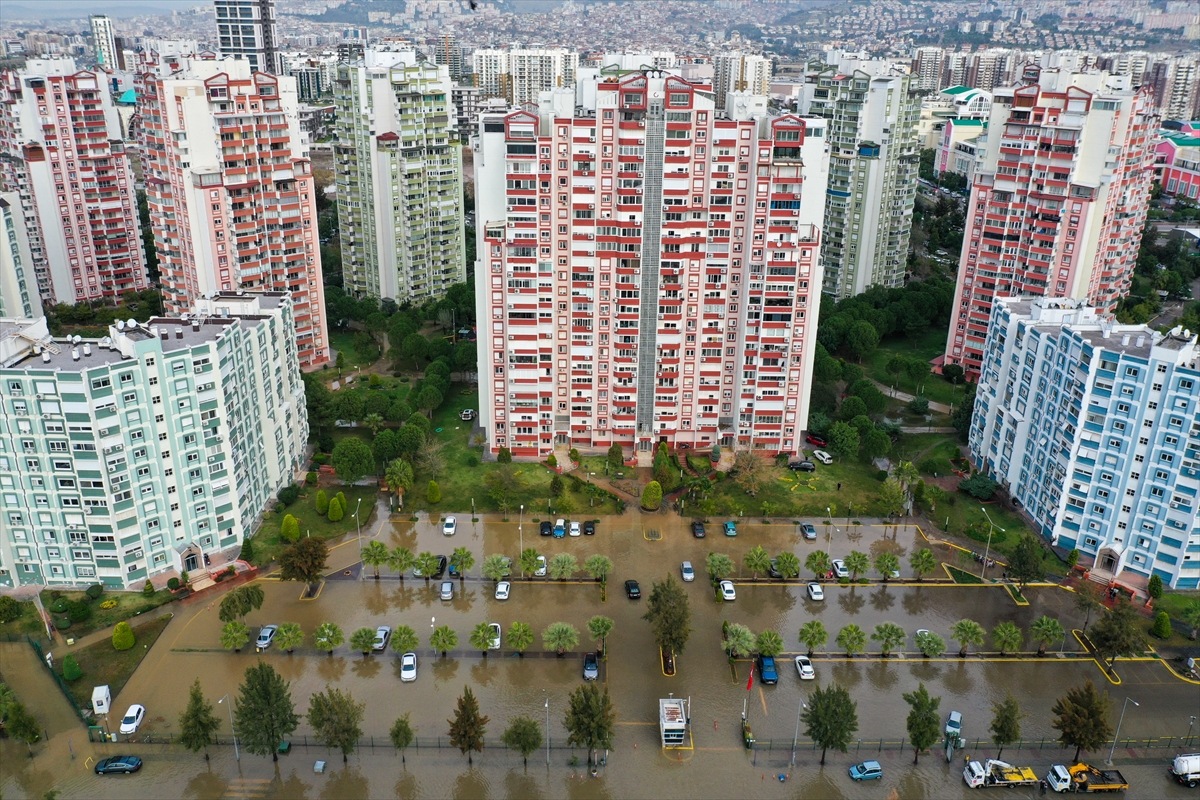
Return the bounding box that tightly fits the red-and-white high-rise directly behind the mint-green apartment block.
[138,59,329,367]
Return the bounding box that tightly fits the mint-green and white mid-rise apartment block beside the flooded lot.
[0,293,308,589]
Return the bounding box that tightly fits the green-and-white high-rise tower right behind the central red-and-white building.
[798,54,920,300]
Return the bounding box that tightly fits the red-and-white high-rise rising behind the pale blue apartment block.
[946,66,1158,379]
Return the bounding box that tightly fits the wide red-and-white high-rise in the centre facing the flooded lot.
[475,72,828,458]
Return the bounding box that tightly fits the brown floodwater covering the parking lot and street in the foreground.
[0,513,1200,798]
